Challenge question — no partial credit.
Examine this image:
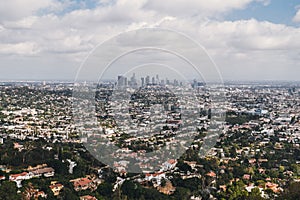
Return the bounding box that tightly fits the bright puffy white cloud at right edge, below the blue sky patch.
[197,19,300,50]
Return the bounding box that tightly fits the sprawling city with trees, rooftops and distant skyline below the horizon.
[0,77,300,200]
